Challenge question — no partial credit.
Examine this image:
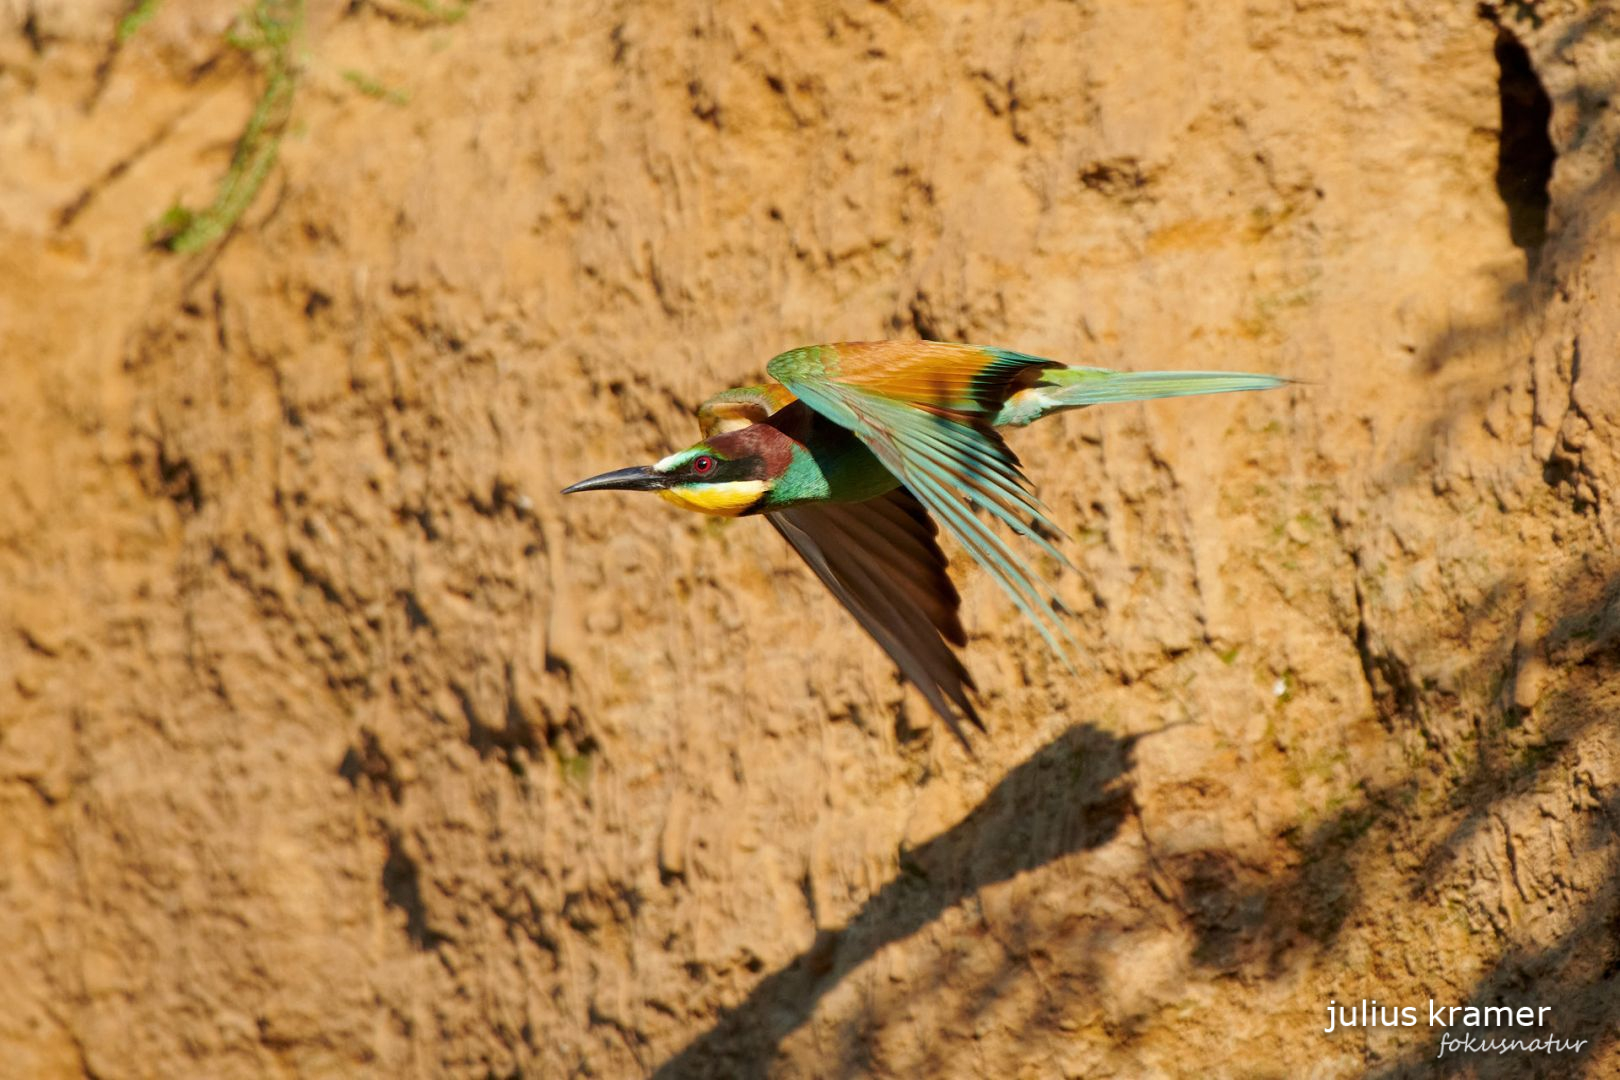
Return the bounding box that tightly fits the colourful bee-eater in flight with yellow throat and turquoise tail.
[562,342,1290,750]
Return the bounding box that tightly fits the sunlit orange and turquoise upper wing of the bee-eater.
[768,342,1074,664]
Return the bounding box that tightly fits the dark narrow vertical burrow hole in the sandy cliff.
[1495,26,1558,274]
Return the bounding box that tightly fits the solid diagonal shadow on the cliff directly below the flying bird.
[654,724,1142,1078]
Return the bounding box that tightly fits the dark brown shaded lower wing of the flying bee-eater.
[765,487,985,751]
